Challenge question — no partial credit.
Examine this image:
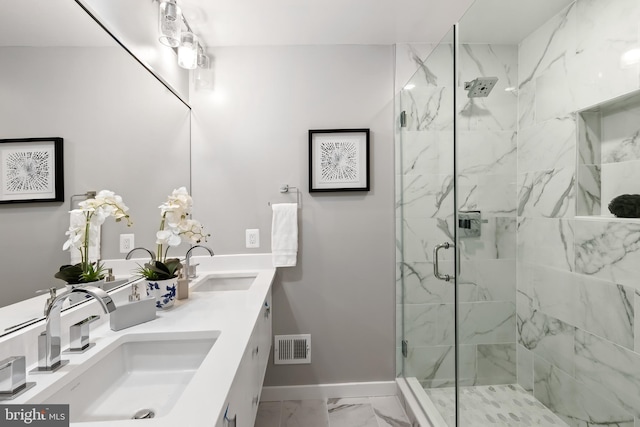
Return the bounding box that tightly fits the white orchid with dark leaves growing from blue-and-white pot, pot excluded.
[138,187,209,280]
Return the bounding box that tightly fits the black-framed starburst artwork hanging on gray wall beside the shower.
[309,129,369,193]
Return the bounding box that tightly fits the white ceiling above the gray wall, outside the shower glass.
[178,0,476,46]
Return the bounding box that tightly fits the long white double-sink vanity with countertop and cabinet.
[0,254,276,427]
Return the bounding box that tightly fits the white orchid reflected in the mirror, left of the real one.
[55,190,132,284]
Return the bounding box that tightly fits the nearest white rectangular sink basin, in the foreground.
[45,333,219,423]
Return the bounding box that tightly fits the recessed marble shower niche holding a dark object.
[576,92,640,218]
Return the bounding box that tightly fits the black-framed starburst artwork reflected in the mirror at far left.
[0,138,64,203]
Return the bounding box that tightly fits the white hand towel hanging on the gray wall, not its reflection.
[271,203,298,267]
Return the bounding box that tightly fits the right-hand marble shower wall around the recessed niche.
[516,0,640,427]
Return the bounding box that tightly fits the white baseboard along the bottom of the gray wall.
[260,381,398,402]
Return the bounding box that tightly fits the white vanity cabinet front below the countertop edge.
[216,290,272,427]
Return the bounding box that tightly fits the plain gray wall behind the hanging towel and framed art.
[190,46,395,386]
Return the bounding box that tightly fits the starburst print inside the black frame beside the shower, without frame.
[319,141,360,183]
